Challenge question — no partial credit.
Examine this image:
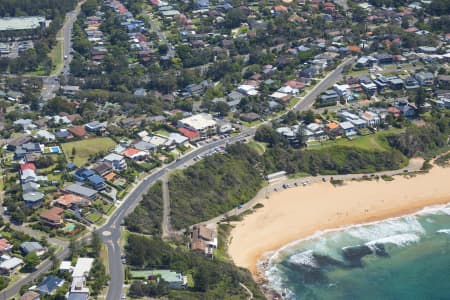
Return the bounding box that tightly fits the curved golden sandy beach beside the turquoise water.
[228,166,450,277]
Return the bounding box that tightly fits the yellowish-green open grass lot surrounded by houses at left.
[61,137,116,167]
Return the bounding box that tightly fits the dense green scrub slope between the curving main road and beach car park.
[169,144,263,229]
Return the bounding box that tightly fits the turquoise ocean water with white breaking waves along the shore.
[265,204,450,300]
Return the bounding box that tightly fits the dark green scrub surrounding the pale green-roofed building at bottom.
[125,234,264,299]
